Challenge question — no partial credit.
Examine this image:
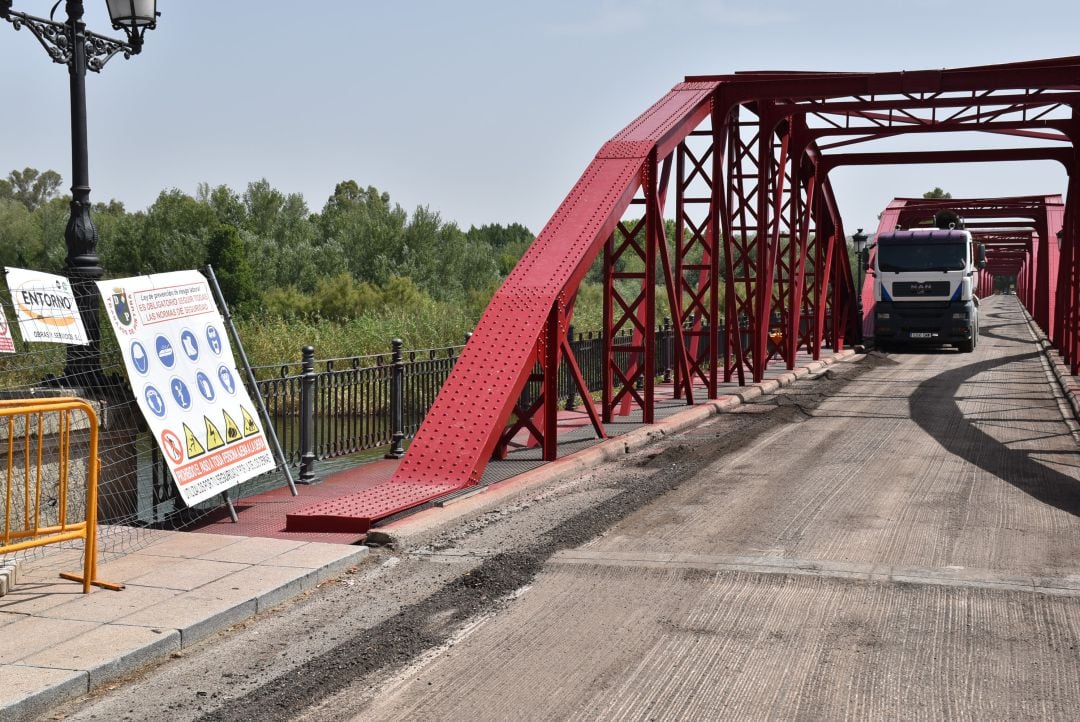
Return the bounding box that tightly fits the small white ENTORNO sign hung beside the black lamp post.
[4,268,87,346]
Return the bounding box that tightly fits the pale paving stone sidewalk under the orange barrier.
[0,532,367,722]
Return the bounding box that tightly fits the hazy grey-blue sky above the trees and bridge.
[0,0,1080,235]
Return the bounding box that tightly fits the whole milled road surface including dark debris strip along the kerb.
[57,297,1080,721]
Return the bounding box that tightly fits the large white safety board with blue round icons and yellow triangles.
[97,271,276,506]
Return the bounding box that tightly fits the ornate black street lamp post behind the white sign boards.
[0,0,158,389]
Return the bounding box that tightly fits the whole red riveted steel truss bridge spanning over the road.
[289,57,1080,532]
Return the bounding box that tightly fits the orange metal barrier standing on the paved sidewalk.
[0,397,123,594]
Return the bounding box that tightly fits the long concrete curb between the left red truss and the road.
[384,349,856,542]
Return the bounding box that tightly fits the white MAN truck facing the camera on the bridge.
[870,228,986,353]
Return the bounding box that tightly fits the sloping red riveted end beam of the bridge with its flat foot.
[288,82,717,532]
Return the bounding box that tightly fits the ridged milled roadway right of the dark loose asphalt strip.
[352,297,1080,719]
